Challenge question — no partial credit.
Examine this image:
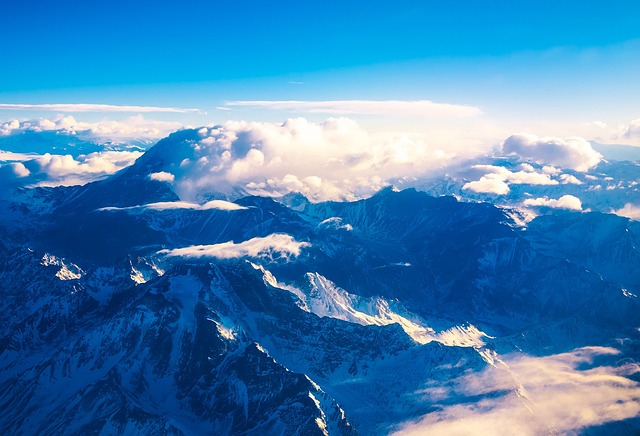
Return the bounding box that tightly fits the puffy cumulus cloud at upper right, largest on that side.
[502,134,602,172]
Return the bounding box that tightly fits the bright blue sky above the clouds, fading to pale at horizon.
[0,0,640,144]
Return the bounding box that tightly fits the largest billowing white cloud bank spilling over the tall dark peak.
[163,118,464,201]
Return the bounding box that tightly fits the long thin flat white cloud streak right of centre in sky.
[225,100,482,117]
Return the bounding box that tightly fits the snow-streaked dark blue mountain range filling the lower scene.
[0,130,640,435]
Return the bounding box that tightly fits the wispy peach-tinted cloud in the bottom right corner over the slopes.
[399,347,640,436]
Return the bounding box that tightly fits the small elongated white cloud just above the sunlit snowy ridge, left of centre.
[158,233,311,259]
